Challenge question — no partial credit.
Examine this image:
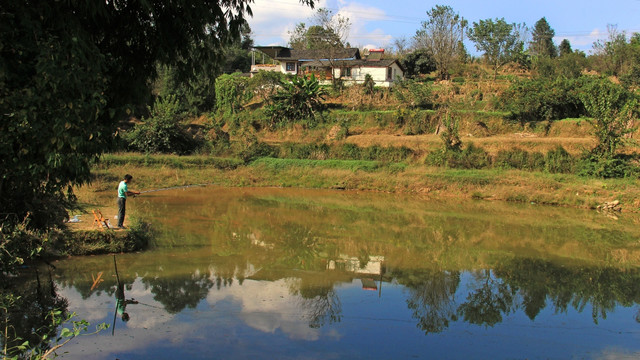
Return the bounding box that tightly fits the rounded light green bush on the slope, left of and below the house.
[216,74,253,116]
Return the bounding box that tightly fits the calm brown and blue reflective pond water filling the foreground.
[38,187,640,359]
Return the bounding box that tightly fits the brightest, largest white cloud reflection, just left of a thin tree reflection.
[207,279,320,340]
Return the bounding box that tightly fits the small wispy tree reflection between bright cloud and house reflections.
[298,280,342,328]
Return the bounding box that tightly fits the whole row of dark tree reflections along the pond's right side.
[392,259,640,333]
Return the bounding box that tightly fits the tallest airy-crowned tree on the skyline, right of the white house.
[413,5,467,80]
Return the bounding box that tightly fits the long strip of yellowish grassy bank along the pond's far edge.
[77,154,640,212]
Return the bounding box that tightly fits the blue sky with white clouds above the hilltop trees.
[249,0,640,53]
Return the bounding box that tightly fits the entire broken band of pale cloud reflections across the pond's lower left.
[55,272,341,360]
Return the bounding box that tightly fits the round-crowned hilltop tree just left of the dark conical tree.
[468,18,522,80]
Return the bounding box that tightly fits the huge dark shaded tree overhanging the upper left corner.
[0,0,313,233]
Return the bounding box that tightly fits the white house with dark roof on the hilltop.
[251,46,404,87]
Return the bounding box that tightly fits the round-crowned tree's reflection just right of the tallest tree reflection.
[458,270,515,326]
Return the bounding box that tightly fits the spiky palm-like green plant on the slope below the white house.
[267,74,326,128]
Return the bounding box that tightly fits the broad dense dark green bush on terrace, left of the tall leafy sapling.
[499,78,585,123]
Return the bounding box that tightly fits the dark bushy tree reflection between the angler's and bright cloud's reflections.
[142,270,213,314]
